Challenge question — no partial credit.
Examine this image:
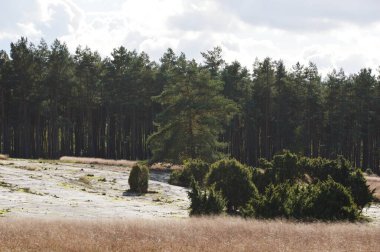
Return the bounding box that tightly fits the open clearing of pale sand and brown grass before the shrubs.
[0,159,380,251]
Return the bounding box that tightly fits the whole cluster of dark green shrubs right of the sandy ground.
[183,151,373,220]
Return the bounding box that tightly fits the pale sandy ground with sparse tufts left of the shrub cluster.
[0,159,189,219]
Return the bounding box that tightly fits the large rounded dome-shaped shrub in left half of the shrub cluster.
[207,159,258,213]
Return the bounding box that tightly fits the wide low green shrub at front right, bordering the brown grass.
[253,177,359,221]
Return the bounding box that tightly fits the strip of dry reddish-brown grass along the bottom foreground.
[0,217,380,251]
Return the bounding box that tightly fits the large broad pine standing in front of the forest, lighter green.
[148,54,236,163]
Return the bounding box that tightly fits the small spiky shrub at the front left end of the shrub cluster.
[188,180,226,215]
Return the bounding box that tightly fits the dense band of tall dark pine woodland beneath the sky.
[0,38,380,173]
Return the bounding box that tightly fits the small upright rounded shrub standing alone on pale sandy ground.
[128,165,149,193]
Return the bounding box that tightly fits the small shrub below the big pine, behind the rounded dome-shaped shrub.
[169,159,210,187]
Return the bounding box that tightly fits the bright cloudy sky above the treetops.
[0,0,380,73]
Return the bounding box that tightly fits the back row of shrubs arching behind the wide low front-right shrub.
[253,151,373,209]
